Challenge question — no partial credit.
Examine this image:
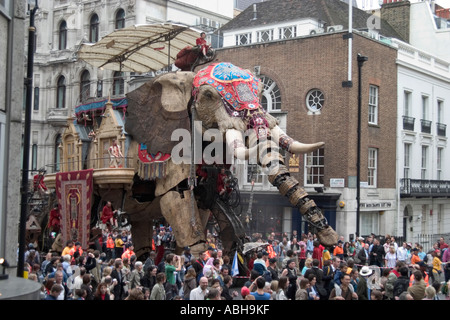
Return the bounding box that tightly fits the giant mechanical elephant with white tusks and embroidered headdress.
[125,63,337,258]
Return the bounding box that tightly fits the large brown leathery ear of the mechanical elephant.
[125,73,192,154]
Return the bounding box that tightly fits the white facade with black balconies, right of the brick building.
[393,40,450,242]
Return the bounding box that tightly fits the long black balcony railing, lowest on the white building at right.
[400,179,450,198]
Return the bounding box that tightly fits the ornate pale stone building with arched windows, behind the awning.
[25,0,233,177]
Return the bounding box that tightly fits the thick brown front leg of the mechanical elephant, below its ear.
[160,190,207,255]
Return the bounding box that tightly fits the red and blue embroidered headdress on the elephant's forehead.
[192,62,270,138]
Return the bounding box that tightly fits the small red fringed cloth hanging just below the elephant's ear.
[138,143,170,180]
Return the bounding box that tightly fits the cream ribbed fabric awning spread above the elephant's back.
[78,23,201,73]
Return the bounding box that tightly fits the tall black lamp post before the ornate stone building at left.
[17,0,39,278]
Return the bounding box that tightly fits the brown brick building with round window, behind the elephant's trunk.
[217,0,397,238]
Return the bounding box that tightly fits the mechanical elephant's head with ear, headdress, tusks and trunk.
[125,62,337,246]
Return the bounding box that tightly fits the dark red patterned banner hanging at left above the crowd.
[56,169,94,249]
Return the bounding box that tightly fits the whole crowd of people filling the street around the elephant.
[19,227,450,300]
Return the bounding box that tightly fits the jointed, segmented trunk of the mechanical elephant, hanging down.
[258,139,338,246]
